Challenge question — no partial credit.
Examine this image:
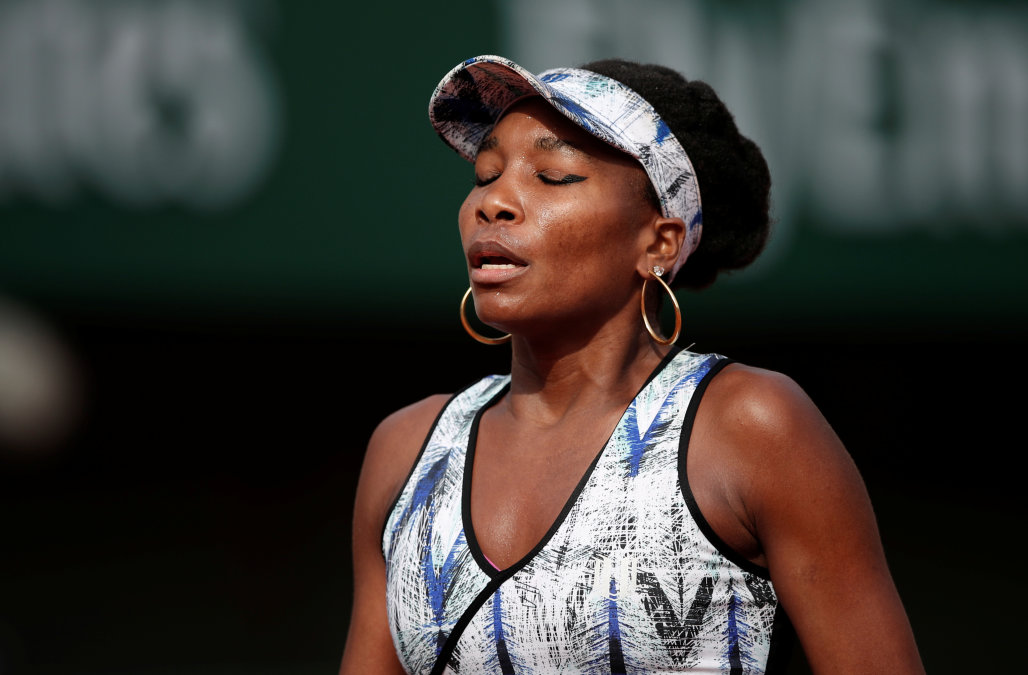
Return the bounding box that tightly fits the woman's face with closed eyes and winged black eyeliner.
[460,98,660,334]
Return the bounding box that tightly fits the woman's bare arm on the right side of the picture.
[707,368,924,673]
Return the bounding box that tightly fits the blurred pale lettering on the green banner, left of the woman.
[0,0,281,210]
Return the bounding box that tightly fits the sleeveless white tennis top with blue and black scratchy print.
[382,351,778,675]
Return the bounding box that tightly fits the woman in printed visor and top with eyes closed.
[341,57,923,674]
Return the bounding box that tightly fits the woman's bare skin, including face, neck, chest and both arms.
[340,99,924,675]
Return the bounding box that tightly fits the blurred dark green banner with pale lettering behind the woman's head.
[0,0,1028,332]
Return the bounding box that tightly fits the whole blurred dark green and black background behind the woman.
[0,0,1028,675]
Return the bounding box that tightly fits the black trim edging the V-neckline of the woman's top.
[461,347,684,578]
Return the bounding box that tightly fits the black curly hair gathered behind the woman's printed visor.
[581,59,771,290]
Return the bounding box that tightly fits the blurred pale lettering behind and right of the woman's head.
[501,0,1028,249]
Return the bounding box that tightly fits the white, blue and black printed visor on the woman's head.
[429,54,703,278]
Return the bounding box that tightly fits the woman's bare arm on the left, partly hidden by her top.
[339,395,448,674]
